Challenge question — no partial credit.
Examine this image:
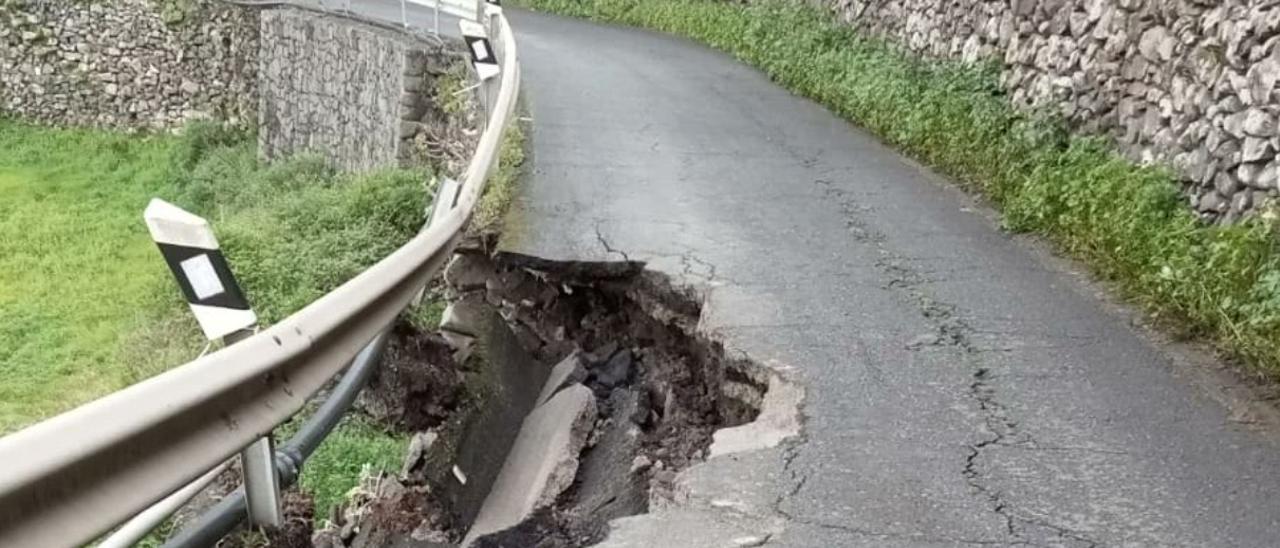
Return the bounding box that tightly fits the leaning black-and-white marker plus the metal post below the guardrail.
[142,198,283,528]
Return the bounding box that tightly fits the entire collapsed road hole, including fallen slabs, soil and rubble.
[305,251,768,548]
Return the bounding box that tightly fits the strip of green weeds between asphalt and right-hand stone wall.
[521,0,1280,375]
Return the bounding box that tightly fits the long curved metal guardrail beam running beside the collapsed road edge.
[0,6,520,548]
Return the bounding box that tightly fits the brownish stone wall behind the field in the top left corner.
[0,0,259,128]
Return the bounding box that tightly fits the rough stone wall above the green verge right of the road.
[827,0,1280,222]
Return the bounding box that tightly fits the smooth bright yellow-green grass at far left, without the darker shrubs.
[0,122,185,433]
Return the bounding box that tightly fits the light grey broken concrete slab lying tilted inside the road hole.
[462,384,596,545]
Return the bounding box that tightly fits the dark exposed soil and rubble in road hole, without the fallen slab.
[468,250,768,548]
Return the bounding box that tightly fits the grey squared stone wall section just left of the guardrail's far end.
[259,9,463,170]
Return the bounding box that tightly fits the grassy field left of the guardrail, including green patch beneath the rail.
[0,122,430,535]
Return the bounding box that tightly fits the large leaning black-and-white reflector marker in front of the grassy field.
[142,198,257,341]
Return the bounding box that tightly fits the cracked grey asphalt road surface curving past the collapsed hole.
[508,10,1280,547]
